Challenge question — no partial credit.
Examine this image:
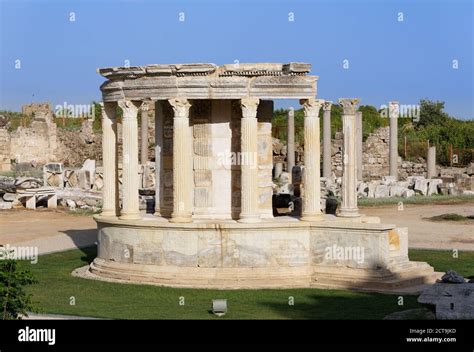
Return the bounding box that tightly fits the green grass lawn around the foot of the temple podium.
[19,248,474,319]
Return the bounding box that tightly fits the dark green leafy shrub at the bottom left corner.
[0,254,37,320]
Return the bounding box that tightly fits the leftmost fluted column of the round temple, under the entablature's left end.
[101,103,120,216]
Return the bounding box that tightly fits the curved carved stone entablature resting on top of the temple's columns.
[98,62,318,102]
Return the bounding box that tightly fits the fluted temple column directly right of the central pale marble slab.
[238,97,261,223]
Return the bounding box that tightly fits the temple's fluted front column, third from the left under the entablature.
[168,98,193,222]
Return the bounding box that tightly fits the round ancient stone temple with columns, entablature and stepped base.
[90,62,433,291]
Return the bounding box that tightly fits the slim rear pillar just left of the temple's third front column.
[154,101,163,217]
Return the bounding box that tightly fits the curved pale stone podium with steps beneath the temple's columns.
[90,216,437,292]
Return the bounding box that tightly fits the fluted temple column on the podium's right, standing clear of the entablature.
[338,98,359,217]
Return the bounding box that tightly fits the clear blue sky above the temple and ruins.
[0,0,474,119]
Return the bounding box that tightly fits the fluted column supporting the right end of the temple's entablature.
[301,98,324,221]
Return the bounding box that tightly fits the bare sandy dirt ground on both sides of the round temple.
[0,202,474,253]
